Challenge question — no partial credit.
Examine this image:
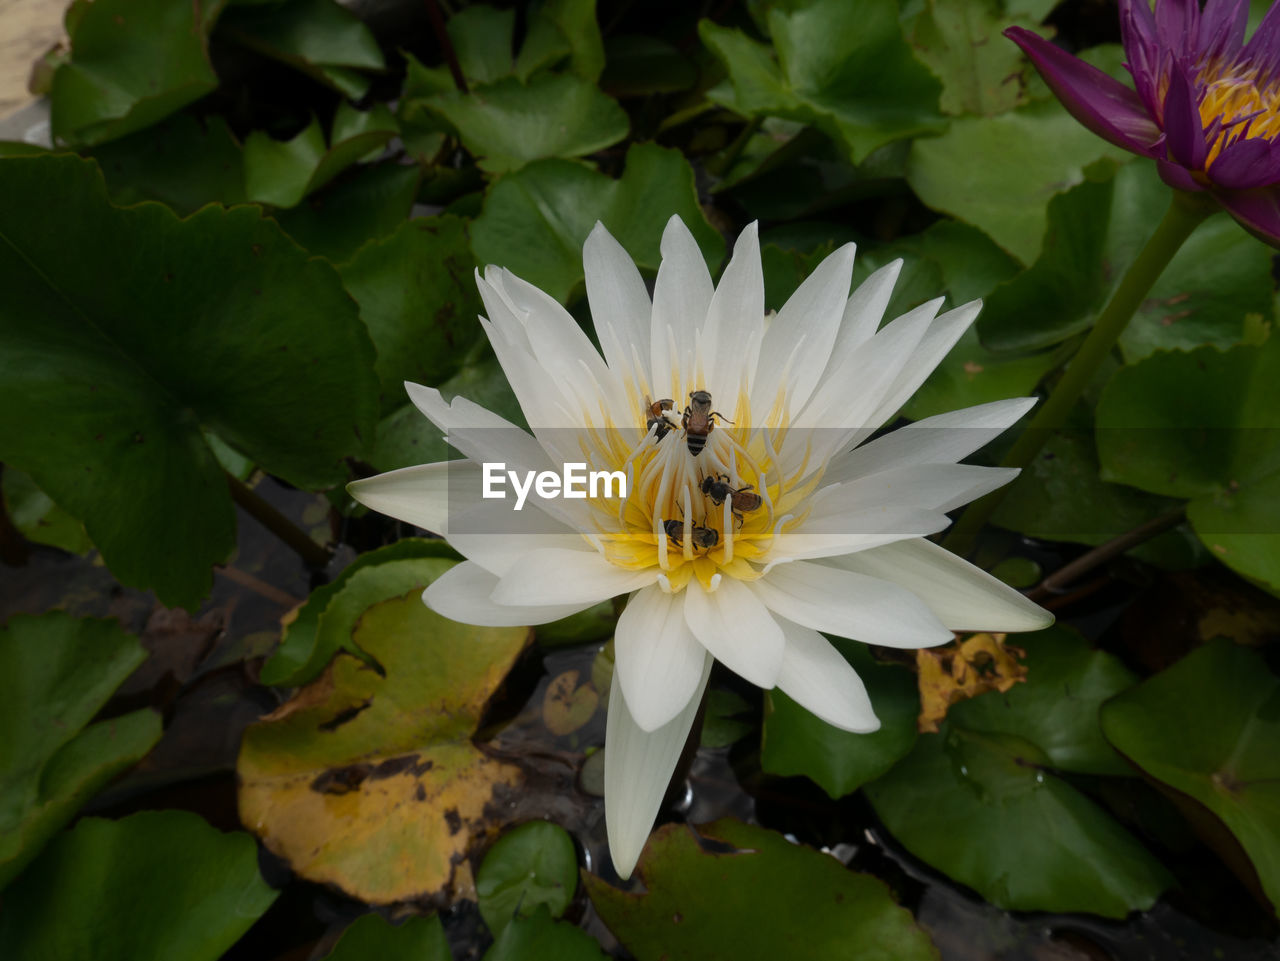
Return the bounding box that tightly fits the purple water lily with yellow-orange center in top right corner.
[1005,0,1280,246]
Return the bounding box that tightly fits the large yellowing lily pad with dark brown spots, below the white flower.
[238,570,530,903]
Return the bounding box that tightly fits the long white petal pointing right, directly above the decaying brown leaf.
[822,540,1053,631]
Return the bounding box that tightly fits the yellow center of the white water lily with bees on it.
[584,385,820,591]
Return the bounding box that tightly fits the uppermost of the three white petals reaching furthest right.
[822,397,1036,484]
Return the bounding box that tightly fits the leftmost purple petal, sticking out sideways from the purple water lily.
[1005,27,1160,157]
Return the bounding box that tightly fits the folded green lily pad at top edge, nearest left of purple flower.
[698,0,943,164]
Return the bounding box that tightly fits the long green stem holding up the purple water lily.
[942,191,1215,555]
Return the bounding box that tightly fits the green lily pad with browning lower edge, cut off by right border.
[1102,640,1280,910]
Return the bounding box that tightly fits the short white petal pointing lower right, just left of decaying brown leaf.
[778,618,879,735]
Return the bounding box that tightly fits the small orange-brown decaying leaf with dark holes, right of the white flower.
[915,633,1027,735]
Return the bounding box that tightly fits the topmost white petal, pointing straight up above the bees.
[649,216,714,399]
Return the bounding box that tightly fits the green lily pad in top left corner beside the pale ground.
[49,0,227,146]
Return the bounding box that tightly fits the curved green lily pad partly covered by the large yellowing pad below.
[259,537,458,687]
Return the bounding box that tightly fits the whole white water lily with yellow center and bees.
[351,218,1052,878]
